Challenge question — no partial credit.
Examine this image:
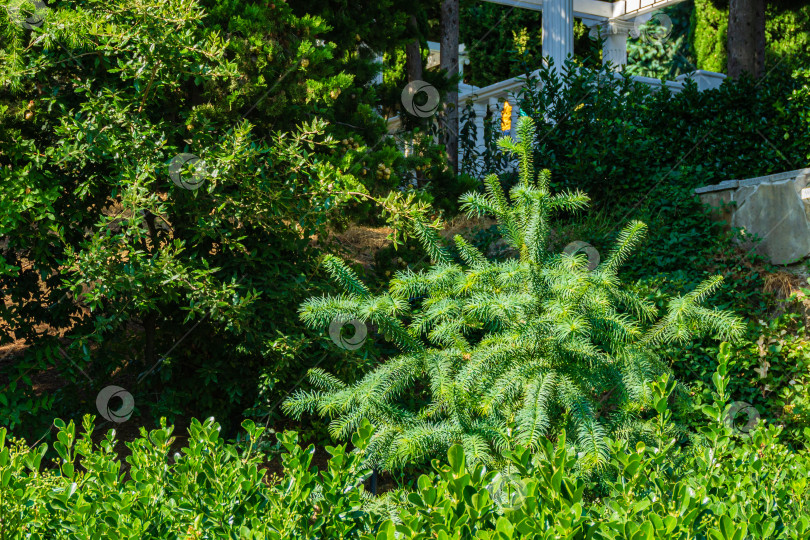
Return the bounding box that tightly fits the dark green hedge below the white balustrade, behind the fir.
[462,64,810,213]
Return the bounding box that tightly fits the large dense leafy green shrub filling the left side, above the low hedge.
[0,1,442,433]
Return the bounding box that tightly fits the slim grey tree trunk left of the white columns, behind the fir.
[439,0,459,173]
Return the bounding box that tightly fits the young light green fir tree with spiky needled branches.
[284,117,741,469]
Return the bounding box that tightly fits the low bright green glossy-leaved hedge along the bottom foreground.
[0,347,810,540]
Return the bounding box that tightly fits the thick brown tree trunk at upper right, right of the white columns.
[728,0,765,79]
